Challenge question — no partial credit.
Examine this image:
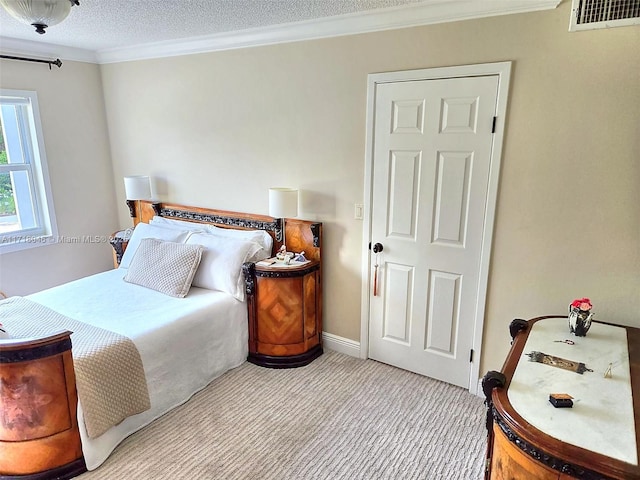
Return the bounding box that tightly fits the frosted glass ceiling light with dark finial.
[0,0,80,34]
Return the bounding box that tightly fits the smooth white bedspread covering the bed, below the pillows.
[27,269,248,470]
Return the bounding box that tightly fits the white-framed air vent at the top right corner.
[569,0,640,32]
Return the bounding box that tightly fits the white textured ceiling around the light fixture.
[0,0,424,51]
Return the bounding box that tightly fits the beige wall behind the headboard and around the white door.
[102,2,640,373]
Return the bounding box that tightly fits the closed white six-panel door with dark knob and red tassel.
[368,75,499,388]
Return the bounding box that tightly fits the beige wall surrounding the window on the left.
[0,60,117,295]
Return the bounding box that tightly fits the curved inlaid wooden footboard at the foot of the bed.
[0,331,86,479]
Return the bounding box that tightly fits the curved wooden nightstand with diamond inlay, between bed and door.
[244,260,322,368]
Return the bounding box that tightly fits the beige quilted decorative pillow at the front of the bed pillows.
[124,238,204,298]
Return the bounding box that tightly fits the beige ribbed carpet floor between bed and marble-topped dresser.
[78,351,486,480]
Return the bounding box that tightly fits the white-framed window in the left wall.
[0,89,56,252]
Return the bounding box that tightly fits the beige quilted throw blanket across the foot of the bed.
[0,297,151,438]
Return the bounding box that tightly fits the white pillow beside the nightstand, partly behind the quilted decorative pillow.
[187,233,268,300]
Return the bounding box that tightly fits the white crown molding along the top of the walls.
[0,0,562,64]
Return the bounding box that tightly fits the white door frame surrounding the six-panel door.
[360,62,511,394]
